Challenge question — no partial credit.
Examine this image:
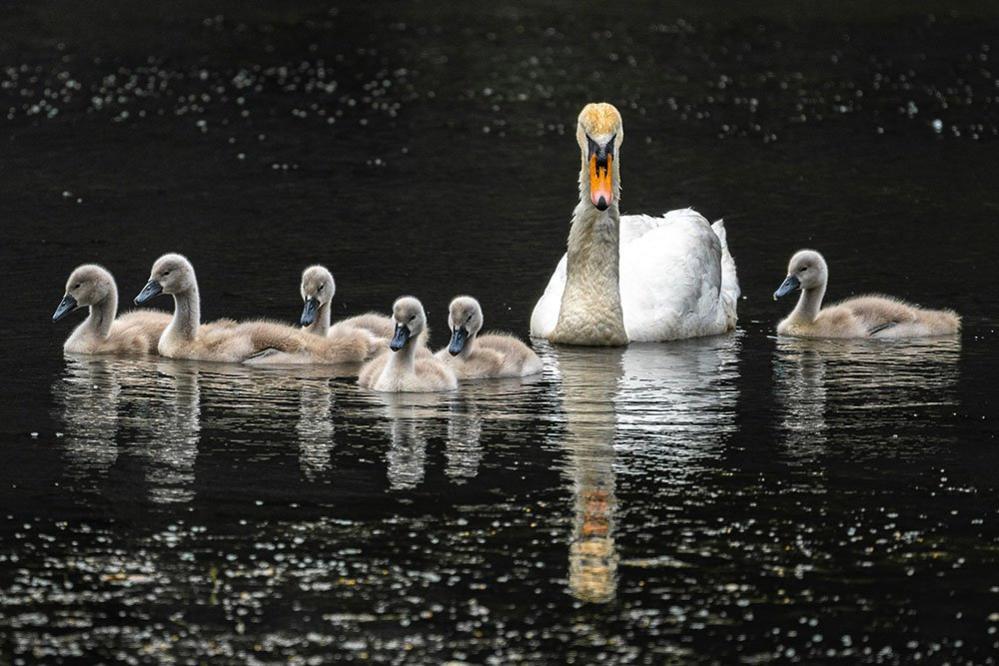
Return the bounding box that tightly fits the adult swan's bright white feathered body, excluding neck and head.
[531,208,739,342]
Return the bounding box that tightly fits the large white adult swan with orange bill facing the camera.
[531,103,739,346]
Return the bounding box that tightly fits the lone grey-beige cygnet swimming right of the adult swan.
[774,250,961,338]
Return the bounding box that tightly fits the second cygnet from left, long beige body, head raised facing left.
[135,253,374,364]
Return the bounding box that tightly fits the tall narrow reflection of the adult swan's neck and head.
[551,348,622,603]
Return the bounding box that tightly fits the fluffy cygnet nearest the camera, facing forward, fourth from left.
[357,296,458,393]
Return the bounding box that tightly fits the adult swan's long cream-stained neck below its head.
[551,154,628,345]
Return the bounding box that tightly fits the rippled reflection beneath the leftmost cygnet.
[52,357,127,484]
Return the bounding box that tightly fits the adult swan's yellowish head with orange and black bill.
[576,102,624,210]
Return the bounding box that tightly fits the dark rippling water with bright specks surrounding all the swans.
[0,1,999,664]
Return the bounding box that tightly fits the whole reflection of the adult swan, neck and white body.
[541,335,739,603]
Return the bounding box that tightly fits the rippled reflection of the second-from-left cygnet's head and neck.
[146,360,201,504]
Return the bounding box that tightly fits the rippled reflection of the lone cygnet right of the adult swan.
[774,337,961,460]
